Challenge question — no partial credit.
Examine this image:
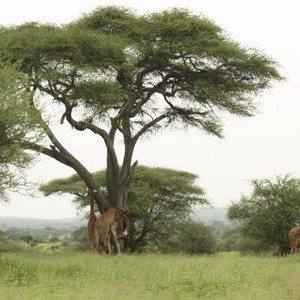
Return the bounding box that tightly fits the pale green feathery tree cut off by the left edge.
[0,62,42,201]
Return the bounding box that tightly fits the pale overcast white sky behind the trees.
[0,0,300,222]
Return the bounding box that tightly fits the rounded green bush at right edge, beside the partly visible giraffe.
[228,176,300,254]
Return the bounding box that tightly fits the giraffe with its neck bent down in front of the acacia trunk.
[94,207,132,255]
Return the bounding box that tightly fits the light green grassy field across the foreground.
[0,252,300,300]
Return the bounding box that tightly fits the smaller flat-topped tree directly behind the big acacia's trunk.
[41,166,209,251]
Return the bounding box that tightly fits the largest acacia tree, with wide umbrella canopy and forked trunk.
[0,7,282,212]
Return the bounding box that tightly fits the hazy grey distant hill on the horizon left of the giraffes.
[0,216,86,228]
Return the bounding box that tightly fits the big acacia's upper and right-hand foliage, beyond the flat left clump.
[74,7,281,136]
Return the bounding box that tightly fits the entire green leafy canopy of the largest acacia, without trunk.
[0,6,282,136]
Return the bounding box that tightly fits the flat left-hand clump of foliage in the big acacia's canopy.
[0,23,122,71]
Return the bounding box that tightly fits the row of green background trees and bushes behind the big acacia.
[0,171,300,255]
